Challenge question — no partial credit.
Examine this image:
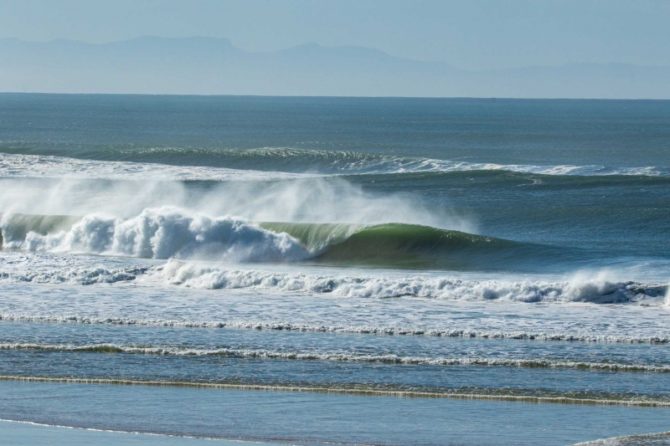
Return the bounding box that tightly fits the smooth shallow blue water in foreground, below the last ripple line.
[0,382,667,445]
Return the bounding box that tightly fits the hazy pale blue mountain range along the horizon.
[0,37,670,99]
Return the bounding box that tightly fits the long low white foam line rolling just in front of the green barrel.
[158,260,666,304]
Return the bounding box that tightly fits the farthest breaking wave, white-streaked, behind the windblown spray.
[0,151,670,181]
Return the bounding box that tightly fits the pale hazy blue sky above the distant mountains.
[0,0,670,68]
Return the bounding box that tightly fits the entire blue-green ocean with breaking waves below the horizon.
[0,94,670,445]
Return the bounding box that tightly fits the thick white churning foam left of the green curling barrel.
[9,207,308,261]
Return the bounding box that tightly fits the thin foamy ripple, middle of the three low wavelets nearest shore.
[0,343,670,373]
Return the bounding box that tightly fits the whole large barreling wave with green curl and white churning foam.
[0,207,570,270]
